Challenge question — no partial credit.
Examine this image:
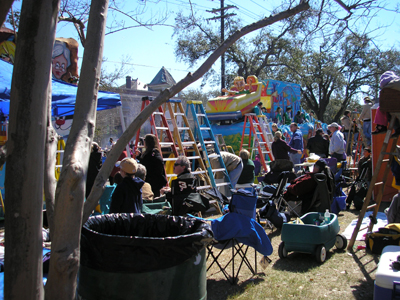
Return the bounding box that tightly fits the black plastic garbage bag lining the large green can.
[81,214,213,273]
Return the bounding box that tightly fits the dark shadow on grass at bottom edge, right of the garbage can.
[207,273,264,300]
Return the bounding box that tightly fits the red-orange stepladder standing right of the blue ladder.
[240,114,273,172]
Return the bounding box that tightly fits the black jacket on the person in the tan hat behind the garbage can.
[110,176,144,214]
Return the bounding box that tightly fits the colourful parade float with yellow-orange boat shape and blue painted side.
[206,75,318,152]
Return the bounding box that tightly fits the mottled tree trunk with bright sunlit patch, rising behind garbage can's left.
[46,0,108,300]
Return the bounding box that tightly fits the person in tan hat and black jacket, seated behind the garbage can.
[110,157,144,214]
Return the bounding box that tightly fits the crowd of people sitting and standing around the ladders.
[86,97,380,218]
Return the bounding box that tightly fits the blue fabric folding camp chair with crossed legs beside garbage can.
[207,190,272,284]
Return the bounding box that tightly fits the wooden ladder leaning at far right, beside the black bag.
[347,113,400,251]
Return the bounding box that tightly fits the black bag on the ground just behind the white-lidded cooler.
[365,223,400,254]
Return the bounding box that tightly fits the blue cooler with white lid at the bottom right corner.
[374,246,400,300]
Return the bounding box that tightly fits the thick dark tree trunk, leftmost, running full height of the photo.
[4,0,59,299]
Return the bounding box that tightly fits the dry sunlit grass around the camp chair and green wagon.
[207,211,379,300]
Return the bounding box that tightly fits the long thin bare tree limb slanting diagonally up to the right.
[83,1,310,222]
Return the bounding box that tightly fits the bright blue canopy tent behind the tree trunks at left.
[0,59,121,117]
